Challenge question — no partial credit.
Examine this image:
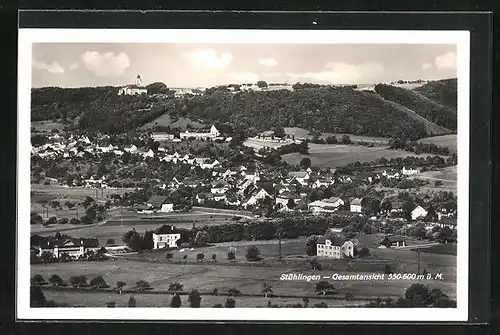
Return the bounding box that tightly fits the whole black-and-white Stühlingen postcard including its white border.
[17,28,470,321]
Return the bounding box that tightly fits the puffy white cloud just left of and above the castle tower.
[80,50,130,77]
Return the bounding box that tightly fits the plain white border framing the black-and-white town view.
[16,28,470,321]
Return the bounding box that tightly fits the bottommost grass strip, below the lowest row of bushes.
[44,290,367,308]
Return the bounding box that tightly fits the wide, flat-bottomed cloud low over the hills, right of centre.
[287,62,384,84]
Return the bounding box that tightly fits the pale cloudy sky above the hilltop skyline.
[32,43,457,88]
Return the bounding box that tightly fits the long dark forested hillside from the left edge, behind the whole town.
[32,86,438,139]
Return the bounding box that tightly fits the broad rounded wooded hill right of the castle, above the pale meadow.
[176,87,427,138]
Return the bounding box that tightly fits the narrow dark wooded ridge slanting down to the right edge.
[375,84,457,131]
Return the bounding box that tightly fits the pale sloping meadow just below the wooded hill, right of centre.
[282,143,438,168]
